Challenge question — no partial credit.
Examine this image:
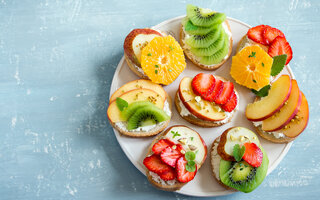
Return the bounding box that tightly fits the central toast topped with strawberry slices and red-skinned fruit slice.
[175,73,239,127]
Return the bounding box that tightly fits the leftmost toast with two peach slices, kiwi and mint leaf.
[107,79,171,137]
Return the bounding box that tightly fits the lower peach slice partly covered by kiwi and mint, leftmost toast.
[107,89,164,123]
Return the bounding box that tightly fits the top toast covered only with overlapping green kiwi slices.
[180,5,232,70]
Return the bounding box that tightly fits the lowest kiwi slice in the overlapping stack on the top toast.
[200,37,229,65]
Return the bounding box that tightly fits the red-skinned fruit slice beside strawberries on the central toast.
[179,77,227,121]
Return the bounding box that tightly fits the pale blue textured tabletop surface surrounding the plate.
[0,0,320,200]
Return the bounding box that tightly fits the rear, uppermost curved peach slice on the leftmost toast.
[109,79,167,102]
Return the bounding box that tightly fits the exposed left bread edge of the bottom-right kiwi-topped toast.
[210,136,236,191]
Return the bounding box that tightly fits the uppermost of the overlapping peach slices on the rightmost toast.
[246,75,291,121]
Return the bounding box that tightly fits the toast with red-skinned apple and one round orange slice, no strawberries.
[123,28,186,85]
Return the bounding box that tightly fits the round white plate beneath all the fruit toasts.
[110,16,294,196]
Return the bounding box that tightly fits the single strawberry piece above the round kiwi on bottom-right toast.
[242,142,263,167]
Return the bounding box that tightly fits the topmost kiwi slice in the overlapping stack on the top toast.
[187,5,226,27]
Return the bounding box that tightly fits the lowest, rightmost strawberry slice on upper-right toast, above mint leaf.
[268,36,292,65]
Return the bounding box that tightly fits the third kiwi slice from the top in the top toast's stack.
[185,25,223,48]
